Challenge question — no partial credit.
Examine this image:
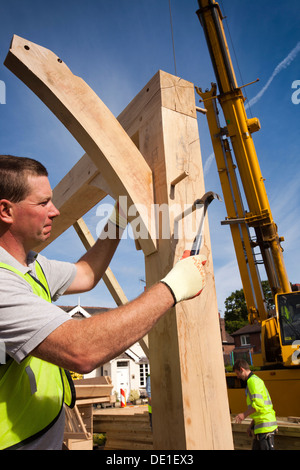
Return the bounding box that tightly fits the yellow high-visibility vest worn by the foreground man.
[0,261,76,450]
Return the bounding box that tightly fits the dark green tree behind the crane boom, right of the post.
[224,281,274,334]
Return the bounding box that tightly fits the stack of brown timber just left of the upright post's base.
[93,406,153,450]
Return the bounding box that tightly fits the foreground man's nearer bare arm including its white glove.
[31,255,206,373]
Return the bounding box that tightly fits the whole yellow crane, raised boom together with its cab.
[196,0,300,416]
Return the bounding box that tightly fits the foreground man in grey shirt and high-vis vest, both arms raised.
[0,155,205,450]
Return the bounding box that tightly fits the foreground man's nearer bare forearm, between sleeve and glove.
[31,283,174,374]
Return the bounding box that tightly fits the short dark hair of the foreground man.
[0,155,48,203]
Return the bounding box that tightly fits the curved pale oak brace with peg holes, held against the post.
[4,35,156,255]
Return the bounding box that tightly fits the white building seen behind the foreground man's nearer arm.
[60,304,150,400]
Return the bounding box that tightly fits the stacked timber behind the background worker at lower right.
[232,418,300,450]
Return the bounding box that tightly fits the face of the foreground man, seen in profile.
[12,176,59,249]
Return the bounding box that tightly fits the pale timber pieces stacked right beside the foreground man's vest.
[64,377,115,450]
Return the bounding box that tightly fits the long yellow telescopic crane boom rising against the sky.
[196,0,291,330]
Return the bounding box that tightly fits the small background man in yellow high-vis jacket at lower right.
[233,359,278,450]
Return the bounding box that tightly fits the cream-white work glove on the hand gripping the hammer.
[160,252,206,305]
